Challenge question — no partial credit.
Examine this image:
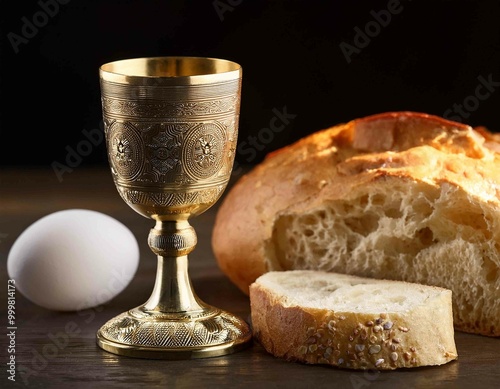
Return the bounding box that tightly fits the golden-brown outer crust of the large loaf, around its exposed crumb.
[212,112,500,336]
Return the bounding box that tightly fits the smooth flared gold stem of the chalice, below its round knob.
[144,255,205,313]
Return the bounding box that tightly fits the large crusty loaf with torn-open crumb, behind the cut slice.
[212,112,500,336]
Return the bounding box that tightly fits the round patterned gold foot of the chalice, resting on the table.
[97,307,251,360]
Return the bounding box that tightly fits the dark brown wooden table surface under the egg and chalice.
[0,167,500,389]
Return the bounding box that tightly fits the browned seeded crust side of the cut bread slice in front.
[249,274,458,370]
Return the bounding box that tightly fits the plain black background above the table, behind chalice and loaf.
[0,0,500,169]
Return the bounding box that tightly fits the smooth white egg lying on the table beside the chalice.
[7,209,139,311]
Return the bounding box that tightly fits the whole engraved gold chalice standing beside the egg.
[97,57,251,359]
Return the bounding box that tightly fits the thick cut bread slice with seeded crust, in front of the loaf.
[249,270,458,370]
